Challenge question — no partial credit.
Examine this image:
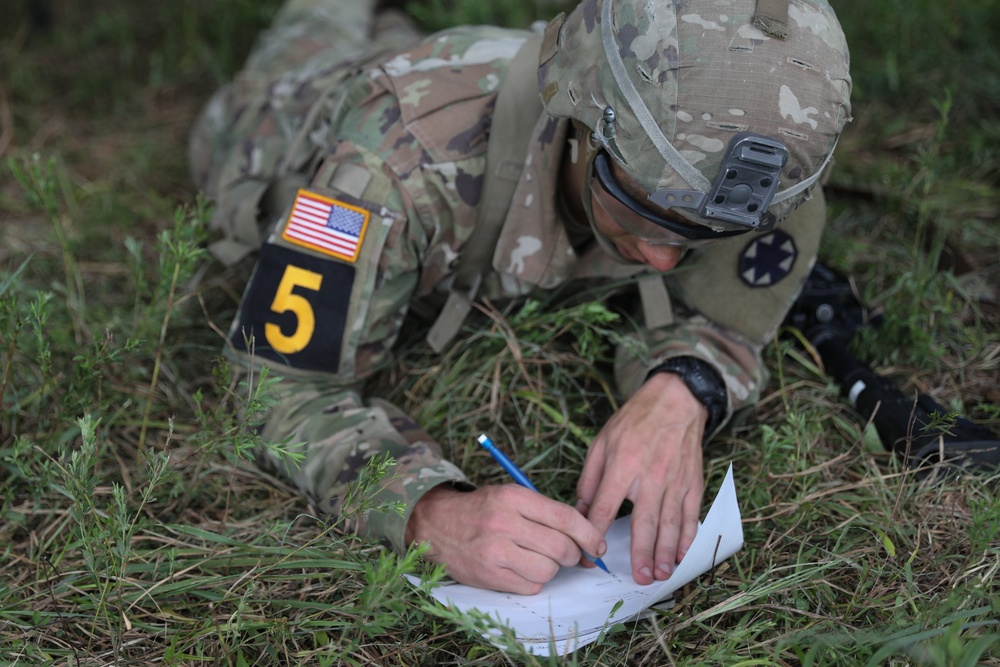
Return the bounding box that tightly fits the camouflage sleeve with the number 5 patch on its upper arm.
[231,136,471,551]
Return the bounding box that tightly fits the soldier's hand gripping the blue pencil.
[406,484,607,595]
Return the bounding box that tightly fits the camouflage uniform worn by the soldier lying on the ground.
[191,0,846,550]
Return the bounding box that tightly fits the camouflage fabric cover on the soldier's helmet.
[538,0,851,226]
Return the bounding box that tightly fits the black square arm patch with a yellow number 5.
[231,243,354,373]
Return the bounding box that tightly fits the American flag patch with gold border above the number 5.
[281,190,369,262]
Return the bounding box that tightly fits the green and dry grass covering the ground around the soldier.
[0,0,1000,666]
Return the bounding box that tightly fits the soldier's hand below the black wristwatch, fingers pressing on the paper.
[577,373,708,584]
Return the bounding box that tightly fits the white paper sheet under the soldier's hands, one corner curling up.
[411,465,743,655]
